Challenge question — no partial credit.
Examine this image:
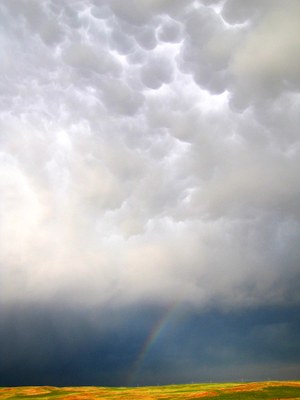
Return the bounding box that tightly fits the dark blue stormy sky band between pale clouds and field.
[0,306,300,386]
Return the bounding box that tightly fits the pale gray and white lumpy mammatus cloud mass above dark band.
[0,0,300,308]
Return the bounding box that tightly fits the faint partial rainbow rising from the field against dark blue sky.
[128,301,179,386]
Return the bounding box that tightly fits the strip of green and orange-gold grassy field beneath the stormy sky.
[0,381,300,400]
